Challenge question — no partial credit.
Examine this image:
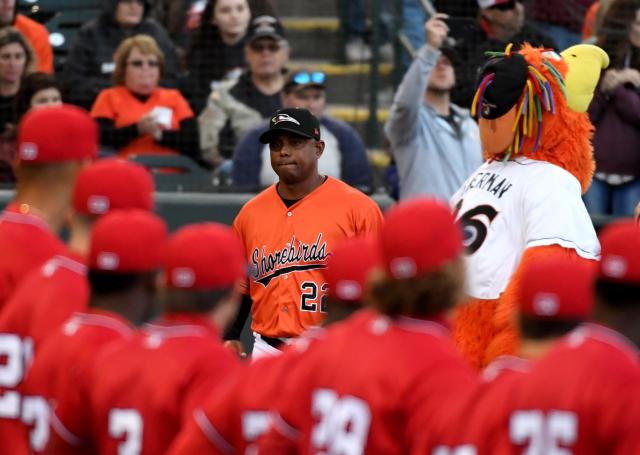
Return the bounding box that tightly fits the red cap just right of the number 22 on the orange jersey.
[324,237,382,303]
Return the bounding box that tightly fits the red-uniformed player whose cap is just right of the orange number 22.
[169,238,379,455]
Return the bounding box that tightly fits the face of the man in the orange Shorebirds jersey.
[269,133,324,185]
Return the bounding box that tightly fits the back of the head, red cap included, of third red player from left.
[89,209,167,297]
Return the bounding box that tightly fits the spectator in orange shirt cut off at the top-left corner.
[0,0,53,73]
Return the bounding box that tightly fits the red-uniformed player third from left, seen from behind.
[22,209,167,453]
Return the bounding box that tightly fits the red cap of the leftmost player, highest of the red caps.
[18,104,99,163]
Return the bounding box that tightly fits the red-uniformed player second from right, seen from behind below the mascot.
[423,254,595,454]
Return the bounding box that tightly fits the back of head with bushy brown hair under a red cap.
[372,198,464,316]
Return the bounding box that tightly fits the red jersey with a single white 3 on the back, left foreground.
[89,314,240,454]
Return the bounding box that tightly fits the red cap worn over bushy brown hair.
[380,198,462,279]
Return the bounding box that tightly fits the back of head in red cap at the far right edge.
[596,220,640,314]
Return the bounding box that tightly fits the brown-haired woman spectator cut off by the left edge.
[0,27,34,176]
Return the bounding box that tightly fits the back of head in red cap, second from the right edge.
[517,254,596,339]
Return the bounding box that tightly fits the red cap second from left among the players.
[73,158,155,215]
